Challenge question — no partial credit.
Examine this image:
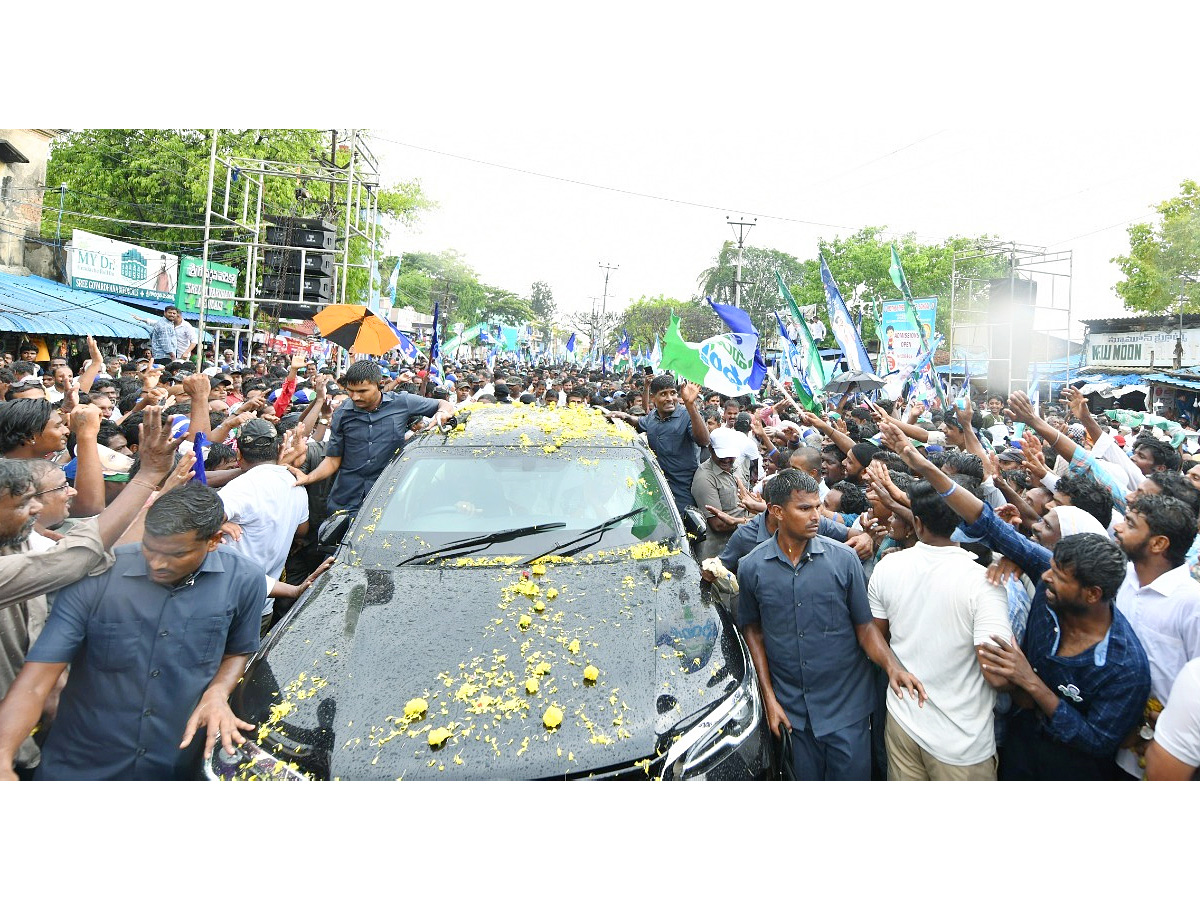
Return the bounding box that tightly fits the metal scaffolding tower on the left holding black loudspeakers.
[199,128,380,359]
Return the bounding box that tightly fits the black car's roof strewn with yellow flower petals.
[422,403,638,454]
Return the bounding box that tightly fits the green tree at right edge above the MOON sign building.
[1110,180,1200,313]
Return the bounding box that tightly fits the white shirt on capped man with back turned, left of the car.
[217,464,308,608]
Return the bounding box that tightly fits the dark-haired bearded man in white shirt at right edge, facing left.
[1116,494,1200,779]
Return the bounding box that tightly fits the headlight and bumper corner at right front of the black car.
[662,635,770,780]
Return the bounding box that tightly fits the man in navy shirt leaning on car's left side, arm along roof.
[296,360,455,512]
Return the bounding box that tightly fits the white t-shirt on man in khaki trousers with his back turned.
[866,544,1012,766]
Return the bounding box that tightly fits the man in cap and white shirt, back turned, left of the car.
[218,419,308,617]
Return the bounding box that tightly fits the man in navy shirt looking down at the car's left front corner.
[0,482,266,780]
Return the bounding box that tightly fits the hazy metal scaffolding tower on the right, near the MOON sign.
[949,241,1073,396]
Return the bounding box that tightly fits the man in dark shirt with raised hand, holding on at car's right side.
[605,374,708,514]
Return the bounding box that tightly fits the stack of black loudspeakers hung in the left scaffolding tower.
[258,217,337,319]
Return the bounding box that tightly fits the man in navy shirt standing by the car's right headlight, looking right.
[737,469,924,780]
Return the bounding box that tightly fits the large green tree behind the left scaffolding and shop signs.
[42,128,432,314]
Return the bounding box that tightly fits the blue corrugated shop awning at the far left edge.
[0,272,150,340]
